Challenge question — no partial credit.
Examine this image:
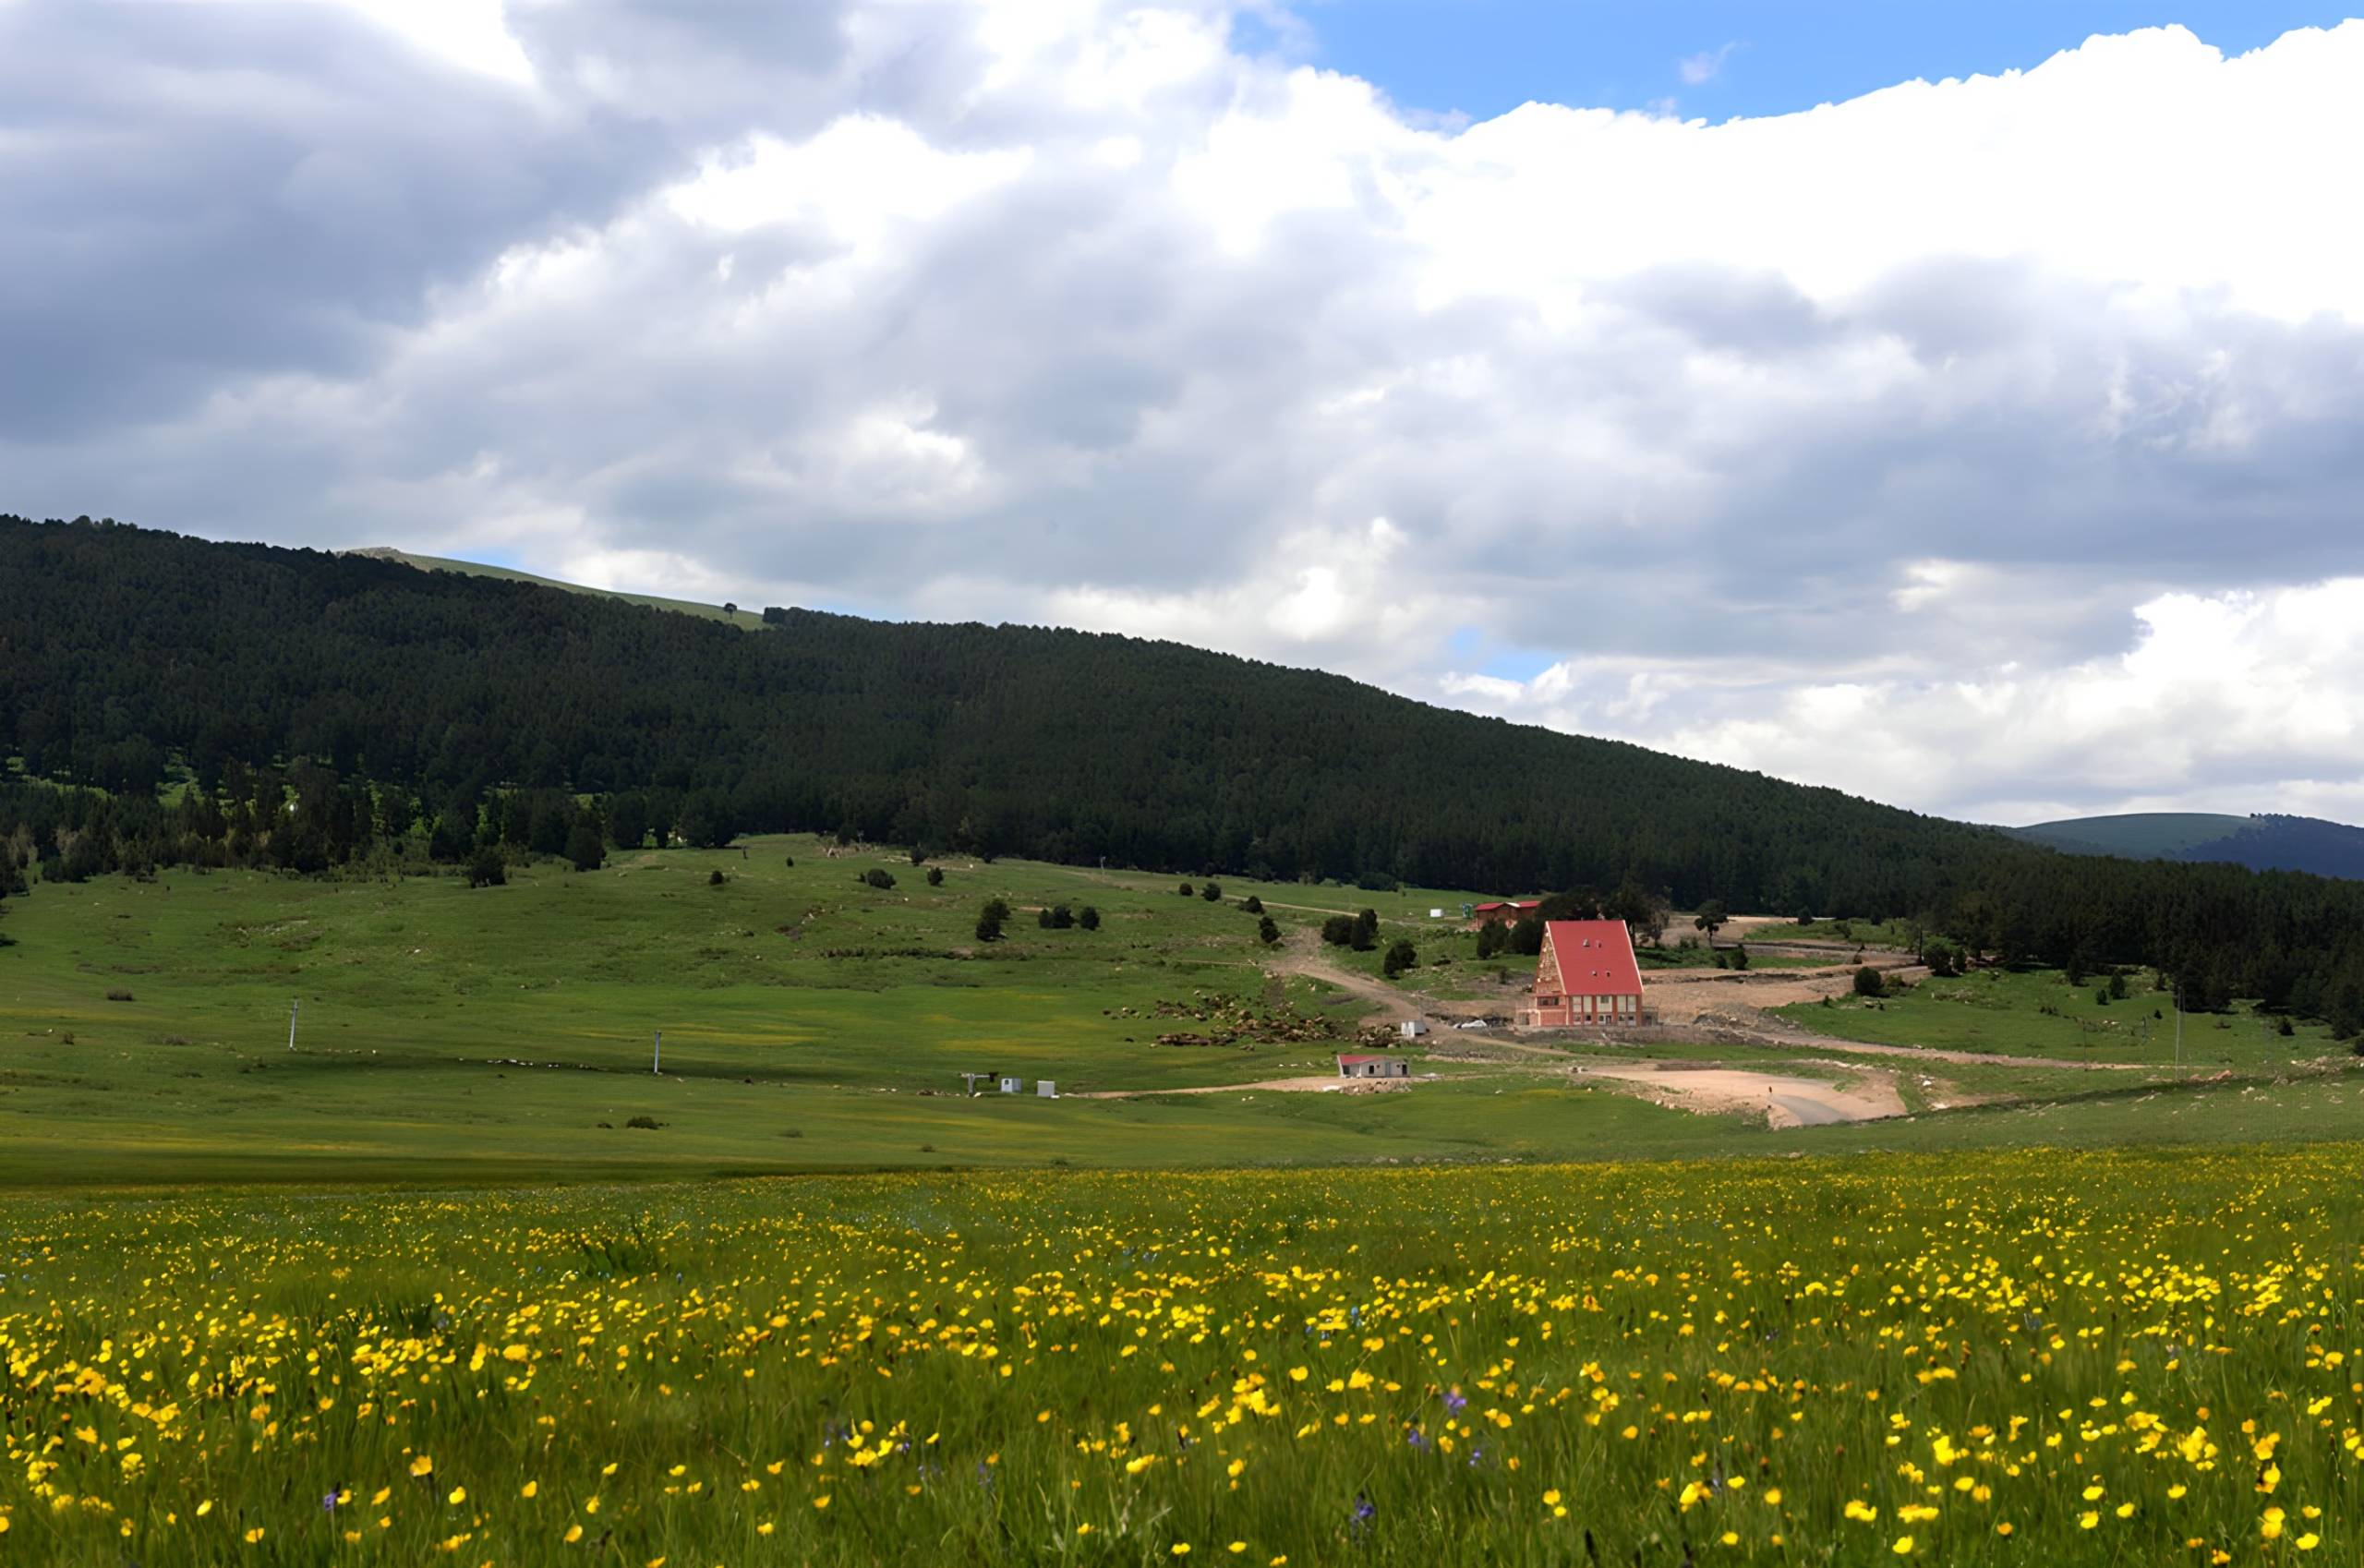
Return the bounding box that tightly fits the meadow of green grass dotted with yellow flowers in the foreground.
[0,1145,2364,1568]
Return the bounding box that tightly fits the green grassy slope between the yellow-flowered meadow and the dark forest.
[0,838,2340,1185]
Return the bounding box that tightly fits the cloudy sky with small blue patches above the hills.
[0,0,2364,823]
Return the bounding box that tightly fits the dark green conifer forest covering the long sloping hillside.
[14,518,2364,1027]
